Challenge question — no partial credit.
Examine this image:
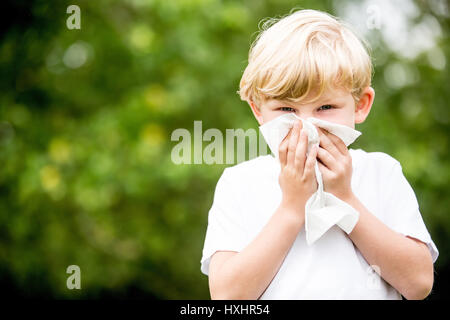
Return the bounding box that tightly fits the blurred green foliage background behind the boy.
[0,0,450,299]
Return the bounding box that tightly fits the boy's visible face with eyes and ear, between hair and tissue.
[252,87,374,128]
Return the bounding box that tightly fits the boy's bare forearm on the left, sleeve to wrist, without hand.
[209,205,304,300]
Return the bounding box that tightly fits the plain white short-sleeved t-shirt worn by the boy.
[201,149,438,300]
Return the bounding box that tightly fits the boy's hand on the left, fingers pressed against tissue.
[278,120,318,216]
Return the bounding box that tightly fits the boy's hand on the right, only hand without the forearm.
[317,128,353,201]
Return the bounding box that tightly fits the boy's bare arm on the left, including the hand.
[209,122,317,299]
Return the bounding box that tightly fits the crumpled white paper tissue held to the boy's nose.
[259,113,361,245]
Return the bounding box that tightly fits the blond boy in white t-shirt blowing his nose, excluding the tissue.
[201,10,438,299]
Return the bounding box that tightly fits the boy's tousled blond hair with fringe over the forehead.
[238,10,372,106]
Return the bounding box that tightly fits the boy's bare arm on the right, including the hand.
[318,130,433,299]
